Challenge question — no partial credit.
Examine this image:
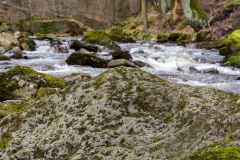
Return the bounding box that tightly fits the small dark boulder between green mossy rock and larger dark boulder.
[70,40,99,53]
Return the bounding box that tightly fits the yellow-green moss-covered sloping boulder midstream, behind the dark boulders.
[82,30,120,49]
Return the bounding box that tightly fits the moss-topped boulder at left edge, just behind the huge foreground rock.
[0,66,66,101]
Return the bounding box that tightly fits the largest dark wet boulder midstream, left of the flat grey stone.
[66,52,107,68]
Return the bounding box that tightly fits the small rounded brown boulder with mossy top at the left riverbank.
[17,36,36,51]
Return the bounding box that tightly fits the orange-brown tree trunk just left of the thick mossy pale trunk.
[173,0,184,24]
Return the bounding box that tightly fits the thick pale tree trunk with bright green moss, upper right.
[182,0,207,31]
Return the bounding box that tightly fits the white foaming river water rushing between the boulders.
[0,37,240,94]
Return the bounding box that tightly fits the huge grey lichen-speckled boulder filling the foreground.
[0,67,240,160]
